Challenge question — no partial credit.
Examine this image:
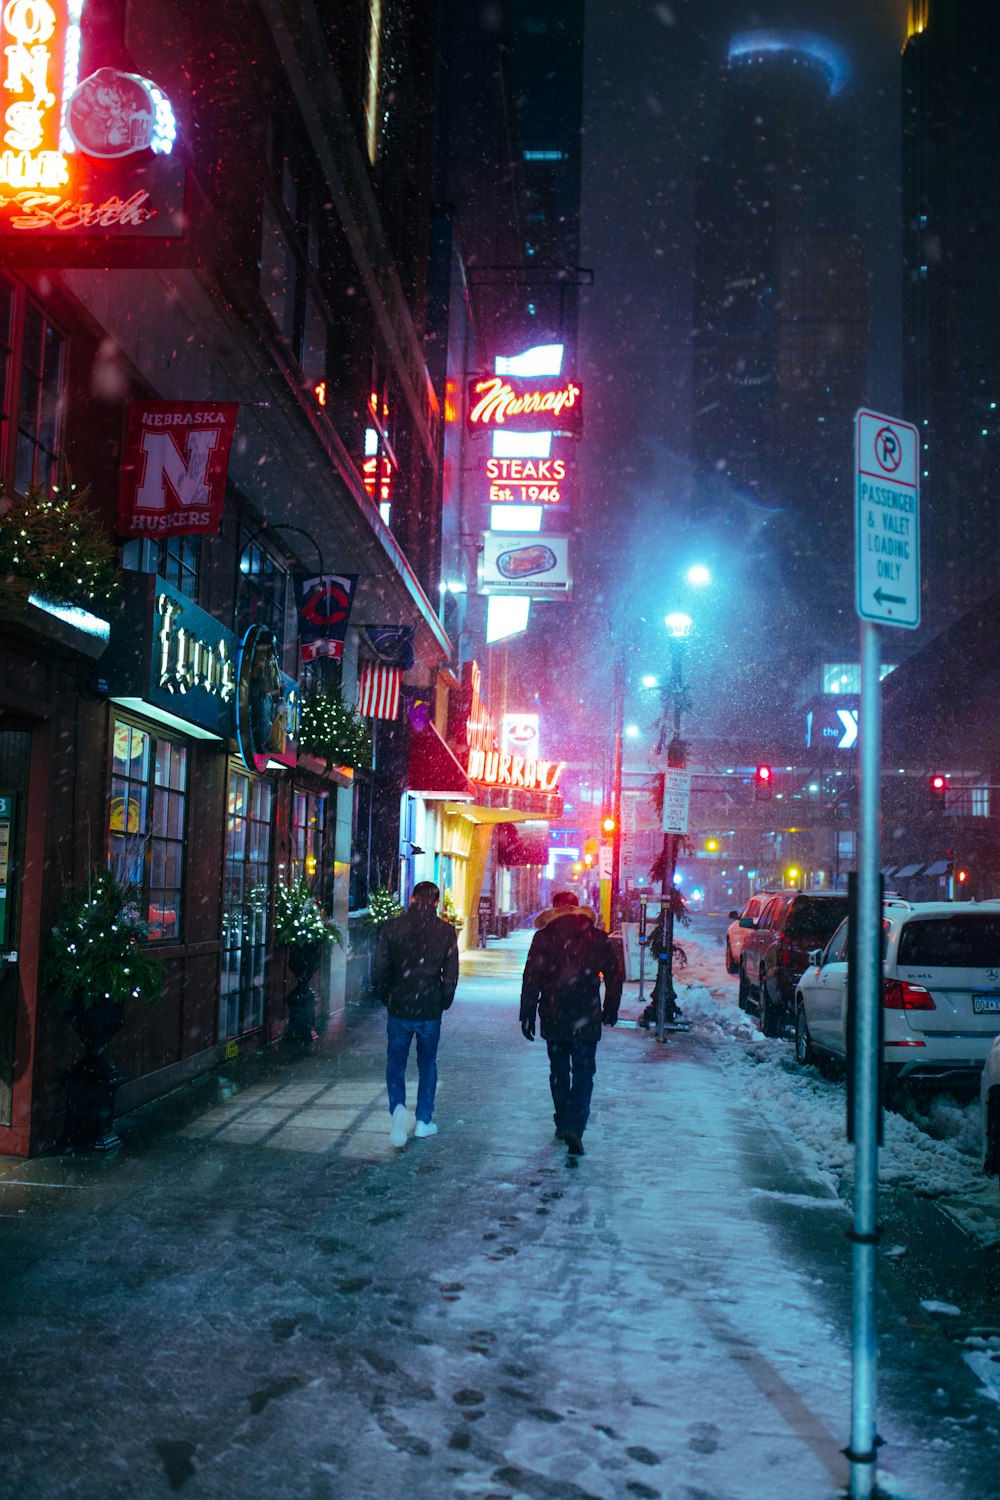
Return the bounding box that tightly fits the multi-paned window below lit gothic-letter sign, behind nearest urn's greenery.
[108,719,187,942]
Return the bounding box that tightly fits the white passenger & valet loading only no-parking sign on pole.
[855,410,921,630]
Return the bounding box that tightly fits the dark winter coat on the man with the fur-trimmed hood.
[520,908,622,1041]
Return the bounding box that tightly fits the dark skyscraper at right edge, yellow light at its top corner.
[903,0,1000,627]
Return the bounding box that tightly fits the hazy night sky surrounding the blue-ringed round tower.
[563,0,906,744]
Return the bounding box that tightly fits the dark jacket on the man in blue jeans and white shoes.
[375,906,459,1022]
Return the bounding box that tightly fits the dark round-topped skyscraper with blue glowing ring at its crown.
[693,32,867,639]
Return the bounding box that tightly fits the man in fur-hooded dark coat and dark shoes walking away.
[520,891,622,1157]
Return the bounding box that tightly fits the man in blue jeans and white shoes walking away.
[375,881,459,1146]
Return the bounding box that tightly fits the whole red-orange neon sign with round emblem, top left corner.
[0,0,184,239]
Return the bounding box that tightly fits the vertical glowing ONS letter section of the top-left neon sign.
[0,0,82,189]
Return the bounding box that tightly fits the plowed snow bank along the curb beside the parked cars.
[665,933,1000,1247]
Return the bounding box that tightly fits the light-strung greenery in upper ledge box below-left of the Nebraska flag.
[0,485,121,612]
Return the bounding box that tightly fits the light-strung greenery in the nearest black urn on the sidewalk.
[45,870,163,1011]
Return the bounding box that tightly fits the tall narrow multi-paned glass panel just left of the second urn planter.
[219,767,274,1037]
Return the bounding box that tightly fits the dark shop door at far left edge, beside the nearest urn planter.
[0,729,31,1125]
